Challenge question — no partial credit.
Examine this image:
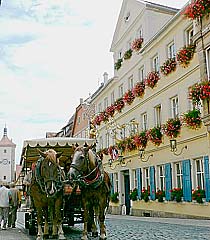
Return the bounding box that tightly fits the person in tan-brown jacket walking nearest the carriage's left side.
[8,182,21,228]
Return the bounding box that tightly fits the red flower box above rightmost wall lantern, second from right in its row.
[163,118,181,138]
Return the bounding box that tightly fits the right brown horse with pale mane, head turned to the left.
[68,146,111,240]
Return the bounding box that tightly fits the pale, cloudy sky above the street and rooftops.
[0,0,187,164]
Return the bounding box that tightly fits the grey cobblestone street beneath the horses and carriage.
[0,212,207,240]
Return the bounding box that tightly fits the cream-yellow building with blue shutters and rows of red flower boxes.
[91,0,210,218]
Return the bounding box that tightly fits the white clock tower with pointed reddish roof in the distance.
[0,126,16,183]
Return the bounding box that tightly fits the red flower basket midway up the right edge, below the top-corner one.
[189,81,210,105]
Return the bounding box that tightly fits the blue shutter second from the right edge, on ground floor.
[182,160,192,202]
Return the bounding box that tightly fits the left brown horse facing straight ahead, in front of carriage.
[30,149,66,240]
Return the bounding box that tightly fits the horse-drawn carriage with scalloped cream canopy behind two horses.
[20,137,95,235]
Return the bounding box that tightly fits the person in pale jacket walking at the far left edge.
[0,186,12,230]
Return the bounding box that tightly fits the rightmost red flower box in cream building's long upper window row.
[176,45,195,68]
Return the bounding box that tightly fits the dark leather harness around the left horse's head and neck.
[35,157,63,198]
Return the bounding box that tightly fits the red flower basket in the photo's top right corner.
[183,0,210,20]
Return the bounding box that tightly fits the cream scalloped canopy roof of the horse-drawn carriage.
[20,137,95,168]
